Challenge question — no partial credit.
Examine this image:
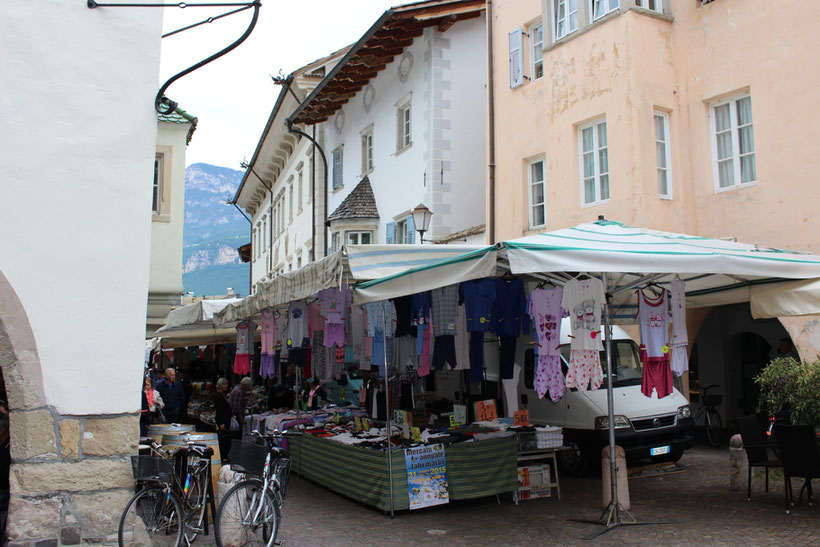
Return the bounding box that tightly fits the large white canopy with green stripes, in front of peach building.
[354,220,820,321]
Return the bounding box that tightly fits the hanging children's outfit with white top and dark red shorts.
[635,290,672,399]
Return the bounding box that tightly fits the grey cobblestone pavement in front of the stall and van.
[266,447,820,547]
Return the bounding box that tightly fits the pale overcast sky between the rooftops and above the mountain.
[158,0,398,169]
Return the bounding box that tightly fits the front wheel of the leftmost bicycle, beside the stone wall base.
[117,486,182,547]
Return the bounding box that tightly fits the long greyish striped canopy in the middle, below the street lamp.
[214,245,494,326]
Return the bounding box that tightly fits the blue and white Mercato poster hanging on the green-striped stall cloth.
[404,444,450,510]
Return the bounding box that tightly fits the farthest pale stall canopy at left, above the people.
[156,298,242,348]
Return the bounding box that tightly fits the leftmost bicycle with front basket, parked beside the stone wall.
[118,440,215,547]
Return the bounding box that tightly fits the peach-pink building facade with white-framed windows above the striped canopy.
[488,0,820,420]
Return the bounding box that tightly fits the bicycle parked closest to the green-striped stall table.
[215,431,290,547]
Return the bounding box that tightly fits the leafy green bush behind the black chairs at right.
[755,358,820,427]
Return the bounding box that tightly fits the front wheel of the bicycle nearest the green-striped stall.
[216,479,279,547]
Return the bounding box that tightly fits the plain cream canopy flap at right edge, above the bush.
[750,279,820,319]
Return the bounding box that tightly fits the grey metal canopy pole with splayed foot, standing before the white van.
[570,272,671,539]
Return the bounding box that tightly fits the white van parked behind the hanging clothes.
[517,318,695,474]
